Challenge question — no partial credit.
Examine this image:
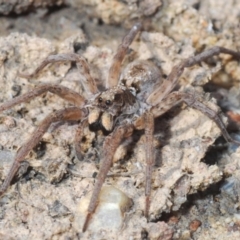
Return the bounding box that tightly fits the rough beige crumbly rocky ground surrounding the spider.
[0,0,240,240]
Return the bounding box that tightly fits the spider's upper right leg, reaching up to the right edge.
[147,46,240,106]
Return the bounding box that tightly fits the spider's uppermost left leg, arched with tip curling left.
[18,53,98,94]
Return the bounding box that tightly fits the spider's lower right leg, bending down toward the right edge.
[151,92,240,145]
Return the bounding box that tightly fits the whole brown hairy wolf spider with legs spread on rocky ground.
[0,23,240,231]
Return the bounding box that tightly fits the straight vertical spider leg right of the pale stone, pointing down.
[144,112,155,218]
